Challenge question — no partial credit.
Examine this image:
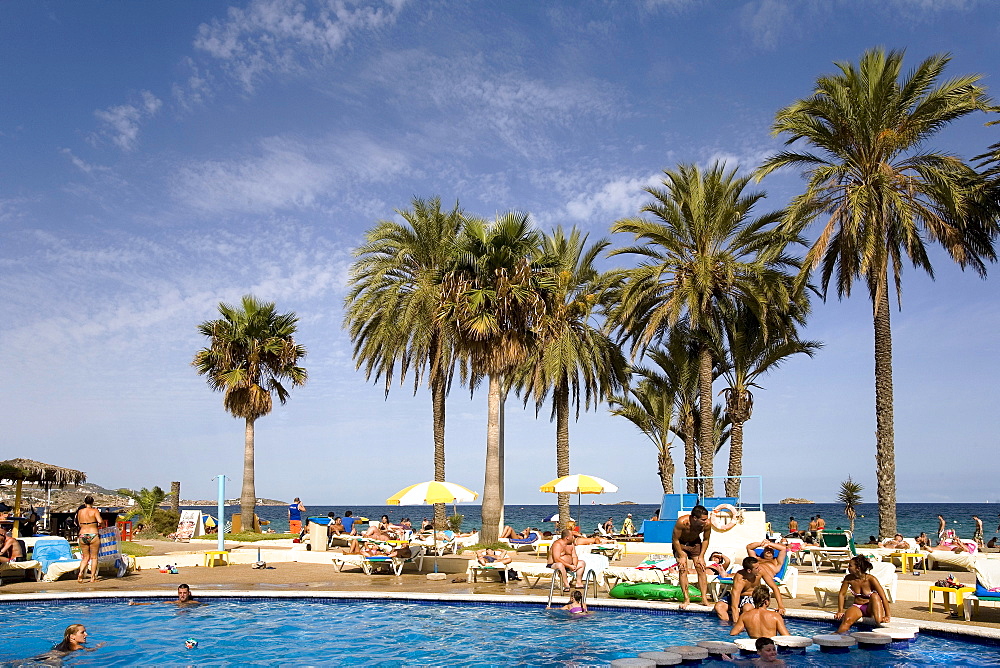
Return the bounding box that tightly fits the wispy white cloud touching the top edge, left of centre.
[194,0,405,91]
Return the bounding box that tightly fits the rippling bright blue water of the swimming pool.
[0,599,1000,666]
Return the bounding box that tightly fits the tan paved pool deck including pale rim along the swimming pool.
[0,541,1000,640]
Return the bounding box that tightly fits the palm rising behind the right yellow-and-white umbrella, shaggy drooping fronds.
[518,226,628,528]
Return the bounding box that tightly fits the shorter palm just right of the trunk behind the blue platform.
[720,308,823,496]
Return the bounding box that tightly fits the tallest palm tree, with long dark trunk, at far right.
[757,49,996,536]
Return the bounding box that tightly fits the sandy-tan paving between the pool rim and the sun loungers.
[0,541,1000,629]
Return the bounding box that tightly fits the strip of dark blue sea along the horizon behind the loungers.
[183,503,1000,542]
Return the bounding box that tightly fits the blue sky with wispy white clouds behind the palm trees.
[0,0,1000,504]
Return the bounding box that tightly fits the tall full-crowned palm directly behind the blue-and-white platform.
[612,163,797,496]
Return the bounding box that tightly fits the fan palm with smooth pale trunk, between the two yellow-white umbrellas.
[440,212,553,543]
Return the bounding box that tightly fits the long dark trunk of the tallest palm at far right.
[874,273,896,536]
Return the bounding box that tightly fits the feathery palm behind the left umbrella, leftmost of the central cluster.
[344,197,465,526]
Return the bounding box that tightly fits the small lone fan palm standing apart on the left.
[192,295,307,527]
